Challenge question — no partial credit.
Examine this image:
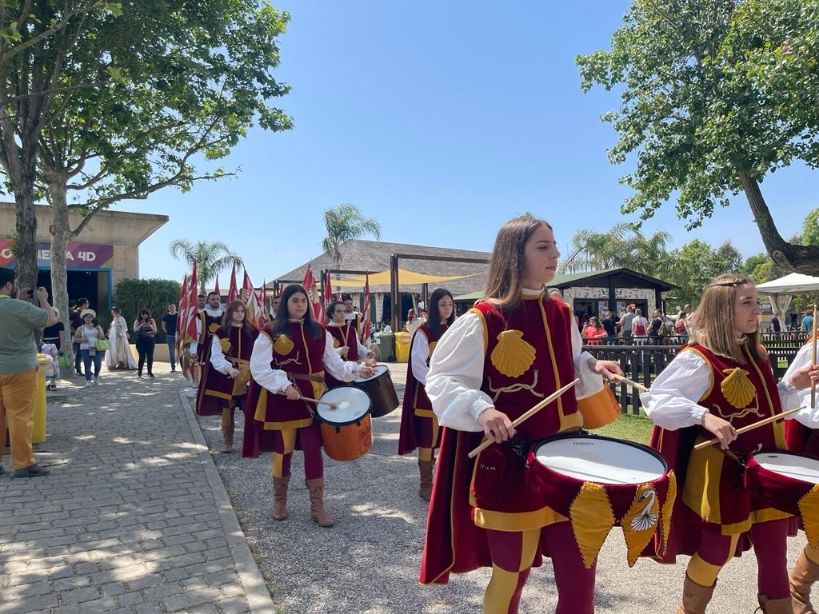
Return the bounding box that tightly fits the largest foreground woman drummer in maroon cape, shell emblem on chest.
[421,215,620,614]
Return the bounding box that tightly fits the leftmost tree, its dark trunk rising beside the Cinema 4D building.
[0,0,118,294]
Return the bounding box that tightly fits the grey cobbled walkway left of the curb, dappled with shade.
[0,365,274,614]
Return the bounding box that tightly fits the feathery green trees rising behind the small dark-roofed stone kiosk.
[561,223,671,275]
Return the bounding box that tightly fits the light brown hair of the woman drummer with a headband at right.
[688,273,765,362]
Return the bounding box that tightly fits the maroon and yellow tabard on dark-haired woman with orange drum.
[248,321,326,430]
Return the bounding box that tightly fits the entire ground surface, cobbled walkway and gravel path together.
[0,365,816,614]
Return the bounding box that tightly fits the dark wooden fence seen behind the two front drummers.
[583,342,801,414]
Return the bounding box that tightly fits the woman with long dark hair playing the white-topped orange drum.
[243,285,373,527]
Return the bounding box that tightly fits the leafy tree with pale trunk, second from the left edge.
[39,0,291,346]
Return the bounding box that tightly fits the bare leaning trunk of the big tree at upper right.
[739,169,819,275]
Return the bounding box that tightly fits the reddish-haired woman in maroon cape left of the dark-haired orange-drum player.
[196,300,259,454]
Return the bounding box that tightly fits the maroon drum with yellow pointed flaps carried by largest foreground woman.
[528,434,677,567]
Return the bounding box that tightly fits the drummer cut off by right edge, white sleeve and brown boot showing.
[782,336,819,614]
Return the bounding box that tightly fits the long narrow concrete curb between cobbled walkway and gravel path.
[179,389,275,614]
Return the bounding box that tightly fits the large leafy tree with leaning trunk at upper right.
[578,0,819,274]
